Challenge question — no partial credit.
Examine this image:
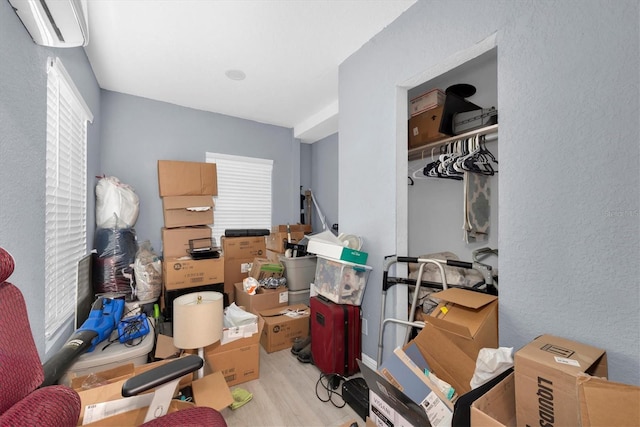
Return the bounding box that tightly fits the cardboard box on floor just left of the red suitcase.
[259,304,311,353]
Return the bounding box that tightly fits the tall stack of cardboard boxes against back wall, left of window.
[158,160,224,308]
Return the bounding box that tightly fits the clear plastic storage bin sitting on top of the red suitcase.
[314,256,373,305]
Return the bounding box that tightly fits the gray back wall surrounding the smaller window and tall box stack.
[100,90,300,252]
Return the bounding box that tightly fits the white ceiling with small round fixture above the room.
[85,0,416,143]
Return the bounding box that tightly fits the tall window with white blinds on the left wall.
[45,58,93,350]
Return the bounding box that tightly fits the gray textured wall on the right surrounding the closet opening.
[339,0,640,384]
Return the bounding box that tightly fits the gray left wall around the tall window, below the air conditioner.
[0,1,101,358]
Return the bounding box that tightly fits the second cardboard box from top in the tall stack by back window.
[162,196,213,228]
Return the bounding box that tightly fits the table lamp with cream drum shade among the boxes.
[173,292,224,378]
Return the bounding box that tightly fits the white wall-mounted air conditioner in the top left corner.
[9,0,89,47]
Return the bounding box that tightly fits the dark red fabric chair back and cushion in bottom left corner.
[0,248,80,426]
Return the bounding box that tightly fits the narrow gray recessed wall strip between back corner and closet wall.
[311,133,338,233]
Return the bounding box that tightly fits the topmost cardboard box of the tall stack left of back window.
[158,160,218,197]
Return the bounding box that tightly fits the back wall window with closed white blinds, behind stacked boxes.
[206,153,273,245]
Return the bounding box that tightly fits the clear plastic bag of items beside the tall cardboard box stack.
[133,240,162,301]
